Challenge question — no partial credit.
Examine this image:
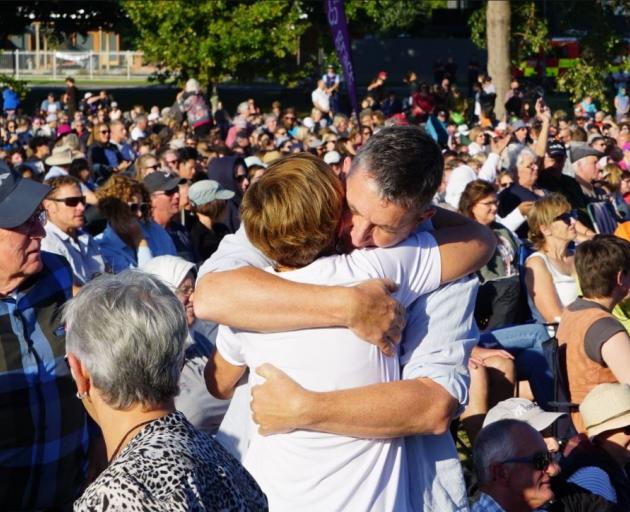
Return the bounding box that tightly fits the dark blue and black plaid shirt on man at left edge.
[0,252,88,510]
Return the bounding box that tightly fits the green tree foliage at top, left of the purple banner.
[123,0,308,85]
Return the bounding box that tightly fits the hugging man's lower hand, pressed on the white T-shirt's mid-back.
[251,363,313,436]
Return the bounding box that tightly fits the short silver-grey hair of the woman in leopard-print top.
[63,270,188,409]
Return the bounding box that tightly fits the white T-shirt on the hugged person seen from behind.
[217,233,441,511]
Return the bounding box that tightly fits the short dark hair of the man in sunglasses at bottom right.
[473,420,540,485]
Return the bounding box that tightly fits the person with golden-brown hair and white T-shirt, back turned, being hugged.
[206,155,488,511]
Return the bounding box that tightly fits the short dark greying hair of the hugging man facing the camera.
[350,126,444,210]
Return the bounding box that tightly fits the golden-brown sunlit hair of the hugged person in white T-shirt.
[241,153,343,267]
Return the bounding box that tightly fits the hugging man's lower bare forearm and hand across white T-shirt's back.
[252,364,458,438]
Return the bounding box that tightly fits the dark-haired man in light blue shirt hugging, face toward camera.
[195,127,494,511]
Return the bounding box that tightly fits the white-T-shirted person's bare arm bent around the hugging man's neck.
[432,208,497,283]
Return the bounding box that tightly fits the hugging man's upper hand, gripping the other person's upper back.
[346,279,405,356]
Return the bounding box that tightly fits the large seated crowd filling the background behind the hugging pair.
[0,65,630,512]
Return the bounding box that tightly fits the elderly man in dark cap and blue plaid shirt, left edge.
[0,162,88,510]
